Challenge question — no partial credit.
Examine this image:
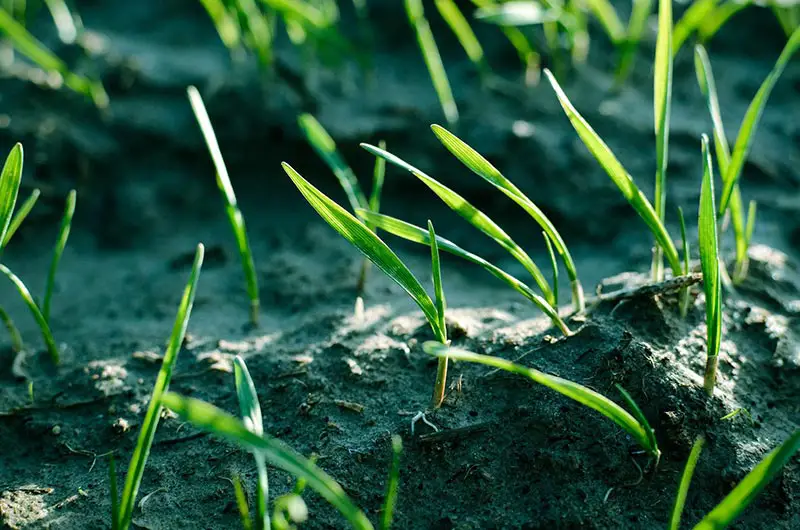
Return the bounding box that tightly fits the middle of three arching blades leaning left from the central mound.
[361,140,553,305]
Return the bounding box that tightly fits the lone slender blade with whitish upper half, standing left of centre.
[186,86,261,325]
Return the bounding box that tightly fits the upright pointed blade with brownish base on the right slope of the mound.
[697,135,722,396]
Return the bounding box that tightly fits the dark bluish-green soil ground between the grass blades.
[0,0,800,530]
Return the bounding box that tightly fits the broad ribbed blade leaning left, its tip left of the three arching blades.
[282,162,444,338]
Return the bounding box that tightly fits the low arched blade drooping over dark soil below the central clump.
[423,341,660,457]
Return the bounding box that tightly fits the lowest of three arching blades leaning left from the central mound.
[357,210,571,335]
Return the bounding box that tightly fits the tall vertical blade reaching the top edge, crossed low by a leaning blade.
[653,0,672,281]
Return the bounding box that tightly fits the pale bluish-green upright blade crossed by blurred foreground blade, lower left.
[233,355,270,530]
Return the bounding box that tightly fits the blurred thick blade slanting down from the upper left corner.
[0,9,108,109]
